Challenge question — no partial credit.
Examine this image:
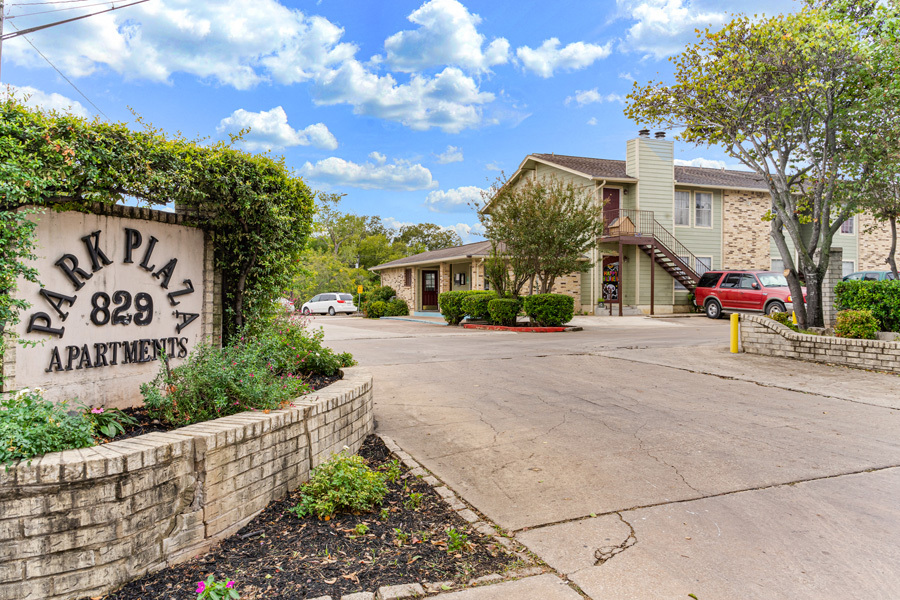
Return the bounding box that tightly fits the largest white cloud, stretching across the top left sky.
[3,0,356,89]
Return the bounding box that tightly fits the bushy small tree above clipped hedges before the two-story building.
[478,177,603,295]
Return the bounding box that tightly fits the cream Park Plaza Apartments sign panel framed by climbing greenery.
[4,207,212,406]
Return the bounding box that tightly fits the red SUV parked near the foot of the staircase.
[694,271,806,319]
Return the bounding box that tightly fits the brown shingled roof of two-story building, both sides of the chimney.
[531,154,769,191]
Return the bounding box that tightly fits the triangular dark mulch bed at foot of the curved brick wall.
[90,435,521,600]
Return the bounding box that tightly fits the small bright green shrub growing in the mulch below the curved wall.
[289,452,388,520]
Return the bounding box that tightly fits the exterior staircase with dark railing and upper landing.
[600,209,700,292]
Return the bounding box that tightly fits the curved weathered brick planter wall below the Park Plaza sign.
[0,368,374,600]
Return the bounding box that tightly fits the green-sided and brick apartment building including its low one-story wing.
[373,130,890,314]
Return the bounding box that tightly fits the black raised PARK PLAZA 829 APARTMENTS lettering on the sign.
[26,227,200,373]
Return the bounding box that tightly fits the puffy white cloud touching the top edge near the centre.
[384,0,509,72]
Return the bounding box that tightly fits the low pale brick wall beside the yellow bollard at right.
[741,314,900,374]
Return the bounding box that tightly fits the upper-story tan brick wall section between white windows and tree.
[713,190,772,269]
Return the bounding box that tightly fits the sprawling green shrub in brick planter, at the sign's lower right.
[141,318,354,427]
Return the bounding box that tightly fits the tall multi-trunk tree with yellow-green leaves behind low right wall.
[625,0,895,326]
